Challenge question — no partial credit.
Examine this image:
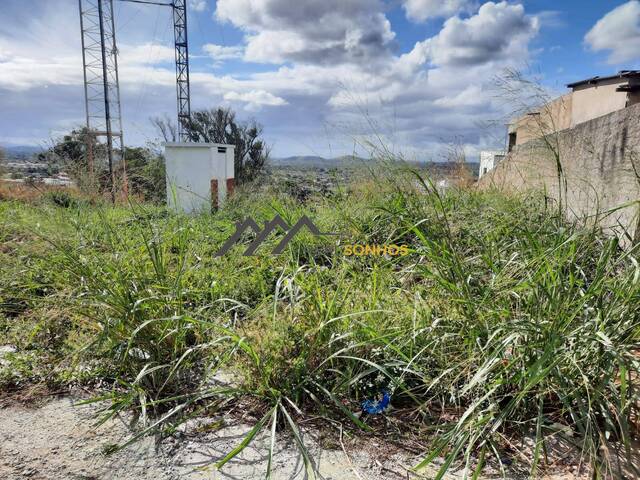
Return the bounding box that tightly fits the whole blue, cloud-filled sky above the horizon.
[0,0,640,161]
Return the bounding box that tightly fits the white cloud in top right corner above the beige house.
[584,0,640,64]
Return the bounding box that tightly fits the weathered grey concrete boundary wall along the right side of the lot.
[479,104,640,240]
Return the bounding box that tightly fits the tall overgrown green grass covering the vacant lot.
[0,166,640,478]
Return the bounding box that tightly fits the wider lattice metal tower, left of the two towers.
[78,0,126,200]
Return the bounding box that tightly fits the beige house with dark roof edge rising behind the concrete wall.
[504,70,640,151]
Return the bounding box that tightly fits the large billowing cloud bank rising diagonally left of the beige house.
[316,2,538,154]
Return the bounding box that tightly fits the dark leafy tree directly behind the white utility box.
[151,108,269,183]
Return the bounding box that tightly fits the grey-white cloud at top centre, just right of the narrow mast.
[216,0,395,64]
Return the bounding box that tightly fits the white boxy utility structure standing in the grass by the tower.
[165,143,235,213]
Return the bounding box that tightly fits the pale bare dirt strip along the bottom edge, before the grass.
[0,397,461,480]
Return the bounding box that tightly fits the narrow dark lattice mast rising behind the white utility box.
[171,0,191,142]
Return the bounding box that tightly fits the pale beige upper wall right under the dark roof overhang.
[571,79,629,127]
